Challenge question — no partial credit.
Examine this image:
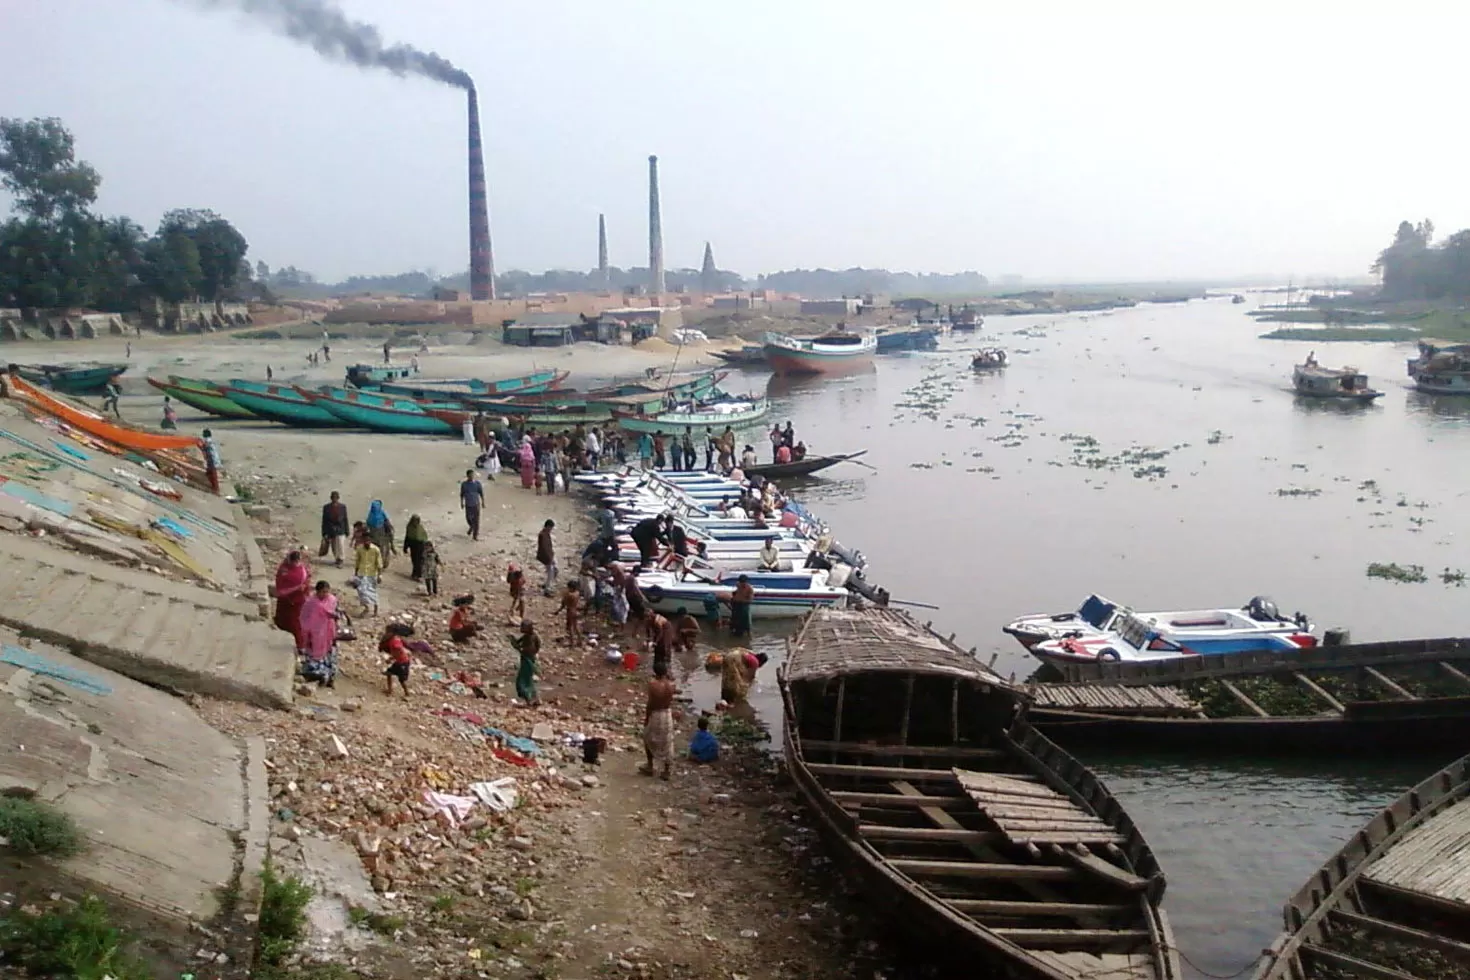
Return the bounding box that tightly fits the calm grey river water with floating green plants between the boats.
[676,300,1470,974]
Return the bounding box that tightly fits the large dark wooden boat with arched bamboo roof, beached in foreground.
[781,608,1182,980]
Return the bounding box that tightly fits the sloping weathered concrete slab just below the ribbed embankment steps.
[0,629,246,921]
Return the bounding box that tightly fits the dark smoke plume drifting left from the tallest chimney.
[184,0,475,90]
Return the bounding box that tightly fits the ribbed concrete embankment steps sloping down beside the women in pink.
[0,535,295,707]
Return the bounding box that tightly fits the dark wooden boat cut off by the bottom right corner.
[1254,757,1470,980]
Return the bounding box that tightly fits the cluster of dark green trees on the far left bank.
[0,118,253,311]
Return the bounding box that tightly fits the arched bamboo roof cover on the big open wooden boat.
[785,607,1004,685]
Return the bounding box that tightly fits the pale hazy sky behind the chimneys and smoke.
[0,0,1470,279]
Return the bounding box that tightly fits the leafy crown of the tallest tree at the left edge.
[0,118,101,222]
